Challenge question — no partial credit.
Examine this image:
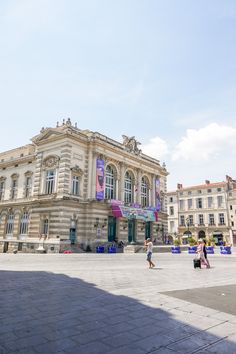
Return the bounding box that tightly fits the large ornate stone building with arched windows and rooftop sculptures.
[0,119,168,253]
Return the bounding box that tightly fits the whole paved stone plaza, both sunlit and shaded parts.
[0,253,236,354]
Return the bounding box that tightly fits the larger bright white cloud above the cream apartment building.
[172,123,236,161]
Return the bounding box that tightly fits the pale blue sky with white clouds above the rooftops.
[0,0,236,190]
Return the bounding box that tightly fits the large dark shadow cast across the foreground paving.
[0,271,236,354]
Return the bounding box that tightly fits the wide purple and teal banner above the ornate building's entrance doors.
[111,204,158,221]
